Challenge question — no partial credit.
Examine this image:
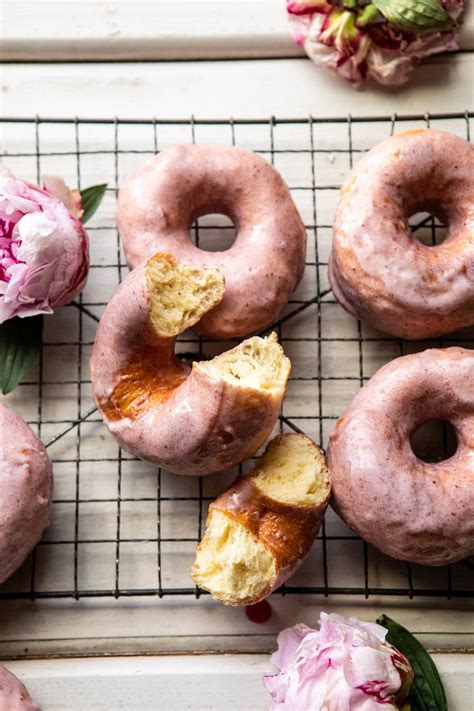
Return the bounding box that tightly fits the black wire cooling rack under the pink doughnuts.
[0,112,474,599]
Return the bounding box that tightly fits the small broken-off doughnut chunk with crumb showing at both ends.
[191,434,330,605]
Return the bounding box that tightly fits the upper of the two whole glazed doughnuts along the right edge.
[329,129,474,338]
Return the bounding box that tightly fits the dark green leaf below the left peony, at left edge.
[0,316,43,395]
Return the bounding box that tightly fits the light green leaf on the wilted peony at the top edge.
[372,0,456,34]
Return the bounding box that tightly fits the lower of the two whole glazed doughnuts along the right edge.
[328,348,474,565]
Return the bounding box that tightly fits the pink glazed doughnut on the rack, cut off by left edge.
[0,404,53,583]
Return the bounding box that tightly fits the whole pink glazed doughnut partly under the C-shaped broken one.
[117,146,306,339]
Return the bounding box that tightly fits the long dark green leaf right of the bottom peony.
[377,615,448,711]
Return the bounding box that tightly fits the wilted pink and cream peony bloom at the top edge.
[287,0,464,85]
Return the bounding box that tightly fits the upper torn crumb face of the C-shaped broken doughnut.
[146,252,224,337]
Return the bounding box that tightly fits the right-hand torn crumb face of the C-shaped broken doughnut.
[195,333,291,391]
